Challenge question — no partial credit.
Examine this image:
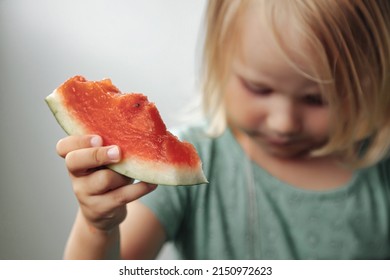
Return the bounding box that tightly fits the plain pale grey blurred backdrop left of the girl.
[0,0,205,259]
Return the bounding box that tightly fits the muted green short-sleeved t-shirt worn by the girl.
[141,123,390,259]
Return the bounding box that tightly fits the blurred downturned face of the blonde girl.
[225,10,329,158]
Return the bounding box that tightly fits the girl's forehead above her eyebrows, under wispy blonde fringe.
[235,0,315,80]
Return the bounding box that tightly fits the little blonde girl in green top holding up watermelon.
[57,0,390,259]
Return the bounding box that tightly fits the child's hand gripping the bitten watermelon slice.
[57,135,156,231]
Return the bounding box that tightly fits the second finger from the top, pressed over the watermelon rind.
[65,146,121,176]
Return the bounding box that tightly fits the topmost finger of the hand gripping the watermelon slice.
[56,135,103,158]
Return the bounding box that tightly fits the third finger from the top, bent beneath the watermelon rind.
[74,168,134,195]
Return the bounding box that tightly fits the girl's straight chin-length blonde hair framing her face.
[202,0,390,167]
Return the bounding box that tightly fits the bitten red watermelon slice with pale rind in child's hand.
[45,76,207,185]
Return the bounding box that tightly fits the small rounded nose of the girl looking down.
[267,101,301,137]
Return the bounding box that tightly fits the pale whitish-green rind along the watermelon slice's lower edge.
[45,90,207,186]
